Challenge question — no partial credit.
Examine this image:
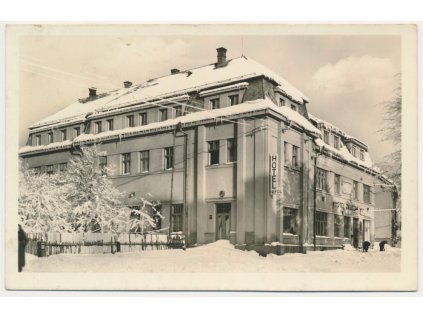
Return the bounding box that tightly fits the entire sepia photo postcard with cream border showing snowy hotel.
[5,24,418,291]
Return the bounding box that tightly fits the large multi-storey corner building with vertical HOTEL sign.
[20,48,388,254]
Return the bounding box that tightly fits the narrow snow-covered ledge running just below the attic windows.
[19,98,321,154]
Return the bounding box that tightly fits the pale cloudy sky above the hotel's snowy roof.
[19,34,401,162]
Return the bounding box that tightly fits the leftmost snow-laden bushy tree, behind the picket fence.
[18,164,71,233]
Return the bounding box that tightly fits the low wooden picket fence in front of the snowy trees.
[25,232,185,257]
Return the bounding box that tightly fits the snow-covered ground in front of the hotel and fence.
[24,241,401,273]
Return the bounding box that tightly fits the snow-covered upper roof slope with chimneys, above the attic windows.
[30,56,308,128]
